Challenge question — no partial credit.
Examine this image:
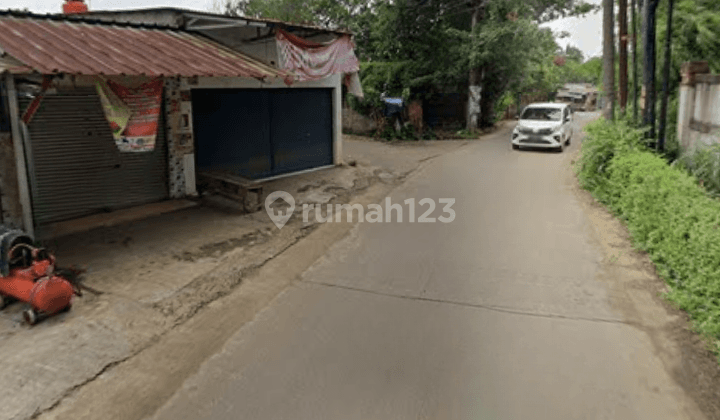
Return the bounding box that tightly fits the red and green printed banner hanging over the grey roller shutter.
[95,79,163,152]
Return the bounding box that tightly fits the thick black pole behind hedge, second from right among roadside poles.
[643,0,659,139]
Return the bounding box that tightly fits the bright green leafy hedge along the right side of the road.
[575,119,720,362]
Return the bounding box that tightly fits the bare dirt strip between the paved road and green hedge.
[565,148,720,419]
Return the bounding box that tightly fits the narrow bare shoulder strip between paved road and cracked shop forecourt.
[34,142,463,420]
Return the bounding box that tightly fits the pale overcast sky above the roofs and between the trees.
[2,0,602,59]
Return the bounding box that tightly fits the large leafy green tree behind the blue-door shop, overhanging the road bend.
[218,0,595,128]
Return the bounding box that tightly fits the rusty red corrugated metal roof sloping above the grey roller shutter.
[0,15,285,78]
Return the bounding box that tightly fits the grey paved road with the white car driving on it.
[150,112,704,420]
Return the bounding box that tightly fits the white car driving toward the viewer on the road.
[511,102,573,152]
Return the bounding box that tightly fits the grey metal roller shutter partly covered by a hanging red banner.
[21,88,168,226]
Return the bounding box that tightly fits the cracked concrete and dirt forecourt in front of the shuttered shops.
[0,135,466,420]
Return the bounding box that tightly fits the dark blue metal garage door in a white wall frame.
[192,89,333,179]
